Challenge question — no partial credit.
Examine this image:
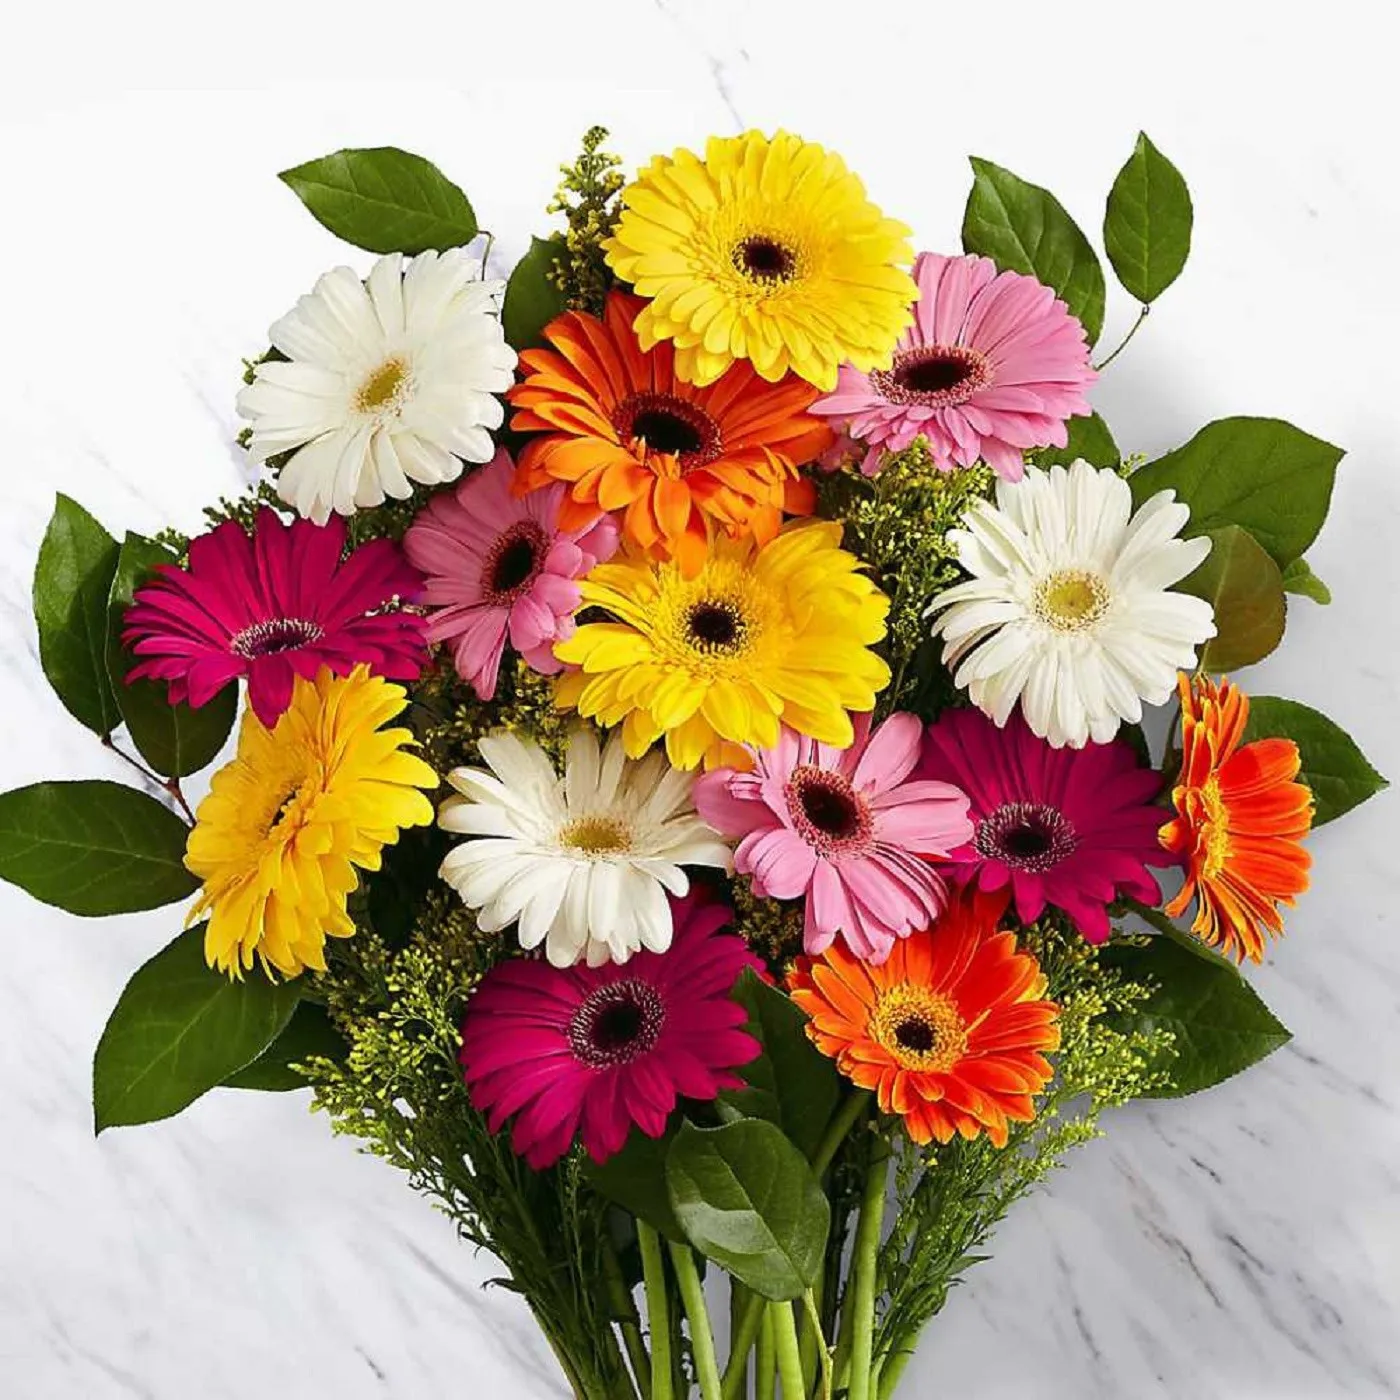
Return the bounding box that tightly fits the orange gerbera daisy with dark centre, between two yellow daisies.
[508,291,832,575]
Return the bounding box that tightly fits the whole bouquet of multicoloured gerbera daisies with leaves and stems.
[0,130,1383,1400]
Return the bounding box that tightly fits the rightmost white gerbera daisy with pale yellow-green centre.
[928,461,1215,749]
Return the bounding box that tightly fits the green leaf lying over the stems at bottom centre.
[666,1119,832,1301]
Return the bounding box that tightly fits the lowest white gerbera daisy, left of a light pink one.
[438,729,732,967]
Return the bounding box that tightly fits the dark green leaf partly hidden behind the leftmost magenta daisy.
[106,533,238,778]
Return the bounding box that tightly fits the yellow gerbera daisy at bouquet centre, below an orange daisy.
[554,521,889,769]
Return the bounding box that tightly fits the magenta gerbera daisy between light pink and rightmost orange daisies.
[918,710,1175,944]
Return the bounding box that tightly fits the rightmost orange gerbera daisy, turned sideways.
[1161,673,1313,962]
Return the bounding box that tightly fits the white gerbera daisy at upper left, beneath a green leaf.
[238,248,515,524]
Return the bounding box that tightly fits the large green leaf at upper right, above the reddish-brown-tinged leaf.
[1128,419,1343,568]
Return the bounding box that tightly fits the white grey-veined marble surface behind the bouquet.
[0,8,1400,1400]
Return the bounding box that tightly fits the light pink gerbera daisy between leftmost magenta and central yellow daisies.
[403,448,617,700]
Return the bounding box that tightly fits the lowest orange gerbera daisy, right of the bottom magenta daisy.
[788,892,1060,1147]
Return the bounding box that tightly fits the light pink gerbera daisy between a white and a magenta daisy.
[694,714,972,963]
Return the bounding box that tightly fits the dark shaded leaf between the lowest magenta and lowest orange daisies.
[720,970,841,1158]
